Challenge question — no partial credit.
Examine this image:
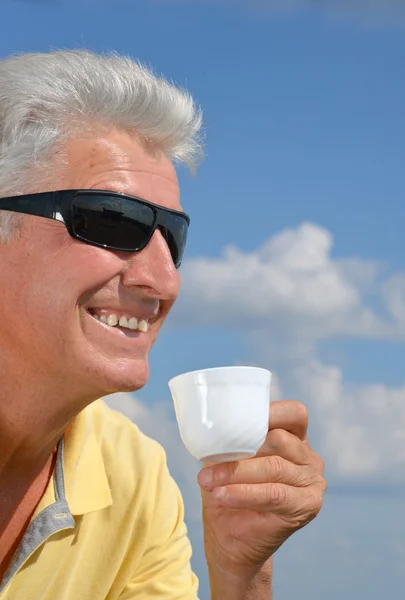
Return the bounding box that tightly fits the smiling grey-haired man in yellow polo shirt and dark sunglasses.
[0,51,325,600]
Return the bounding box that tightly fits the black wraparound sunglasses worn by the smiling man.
[0,190,190,268]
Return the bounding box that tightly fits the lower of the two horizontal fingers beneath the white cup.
[208,478,325,522]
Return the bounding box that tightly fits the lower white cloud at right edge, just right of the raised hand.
[291,360,405,484]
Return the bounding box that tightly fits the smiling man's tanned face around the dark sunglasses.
[0,130,181,397]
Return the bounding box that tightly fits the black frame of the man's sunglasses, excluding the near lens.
[0,189,190,268]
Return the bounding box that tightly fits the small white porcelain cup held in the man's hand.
[169,367,271,462]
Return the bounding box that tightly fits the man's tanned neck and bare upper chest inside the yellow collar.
[0,353,102,581]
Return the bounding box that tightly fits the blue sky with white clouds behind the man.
[0,0,405,600]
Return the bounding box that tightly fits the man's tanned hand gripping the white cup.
[198,400,326,576]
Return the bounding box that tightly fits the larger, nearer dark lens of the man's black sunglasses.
[72,194,156,252]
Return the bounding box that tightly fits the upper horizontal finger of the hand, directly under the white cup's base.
[198,456,315,492]
